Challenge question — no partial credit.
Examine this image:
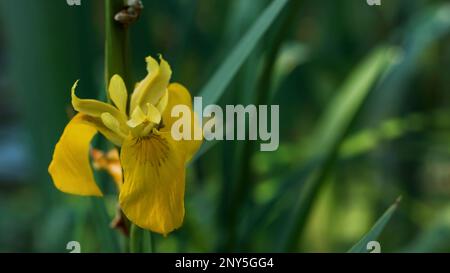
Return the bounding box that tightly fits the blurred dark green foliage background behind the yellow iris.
[0,0,450,252]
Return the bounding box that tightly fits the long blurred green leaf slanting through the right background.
[277,47,396,251]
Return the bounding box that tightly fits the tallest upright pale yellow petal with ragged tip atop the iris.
[131,56,172,110]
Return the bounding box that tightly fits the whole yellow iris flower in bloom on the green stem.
[49,54,202,235]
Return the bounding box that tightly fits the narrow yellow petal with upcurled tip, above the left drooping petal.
[72,81,125,123]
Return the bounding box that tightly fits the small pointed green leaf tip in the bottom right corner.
[348,197,401,253]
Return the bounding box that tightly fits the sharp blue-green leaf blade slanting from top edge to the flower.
[200,0,288,105]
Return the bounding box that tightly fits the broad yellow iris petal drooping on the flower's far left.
[48,114,102,196]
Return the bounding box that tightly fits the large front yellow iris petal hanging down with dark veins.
[119,134,185,235]
